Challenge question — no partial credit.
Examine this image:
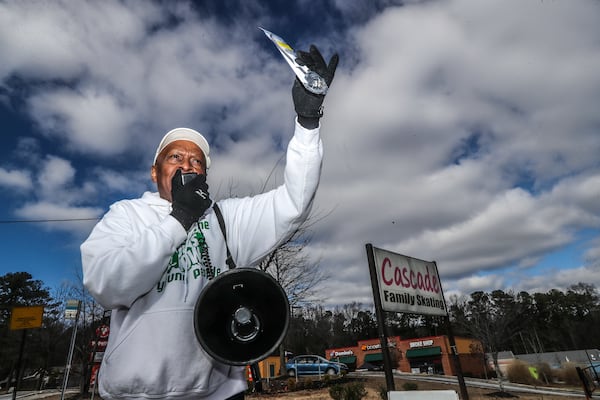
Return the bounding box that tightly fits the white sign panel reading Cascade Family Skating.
[373,247,446,315]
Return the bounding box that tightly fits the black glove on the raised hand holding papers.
[292,45,340,129]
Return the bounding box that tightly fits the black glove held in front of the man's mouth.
[171,169,212,231]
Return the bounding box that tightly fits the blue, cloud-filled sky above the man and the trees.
[0,0,600,307]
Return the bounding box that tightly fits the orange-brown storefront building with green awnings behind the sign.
[325,335,486,377]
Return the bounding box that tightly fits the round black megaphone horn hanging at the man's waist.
[194,268,290,365]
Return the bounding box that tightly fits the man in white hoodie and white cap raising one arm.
[81,46,338,400]
